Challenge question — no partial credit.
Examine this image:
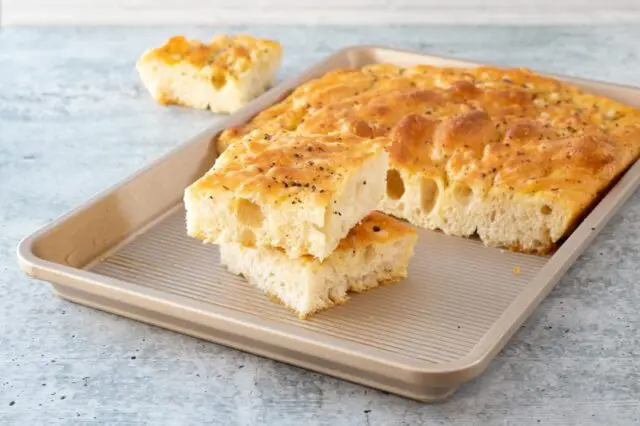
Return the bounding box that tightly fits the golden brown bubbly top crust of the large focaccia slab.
[220,65,640,250]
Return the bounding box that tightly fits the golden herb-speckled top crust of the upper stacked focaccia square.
[192,132,387,205]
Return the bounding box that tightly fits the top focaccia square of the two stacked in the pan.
[184,133,388,260]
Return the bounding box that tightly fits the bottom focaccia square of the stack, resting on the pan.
[220,212,417,319]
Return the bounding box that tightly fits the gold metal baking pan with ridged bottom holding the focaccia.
[18,46,640,401]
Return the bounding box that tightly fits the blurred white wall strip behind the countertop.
[0,0,640,25]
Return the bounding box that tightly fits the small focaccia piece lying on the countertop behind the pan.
[136,35,282,113]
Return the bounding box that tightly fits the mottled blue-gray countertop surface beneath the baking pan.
[0,26,640,425]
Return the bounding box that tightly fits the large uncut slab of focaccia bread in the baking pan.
[219,65,640,254]
